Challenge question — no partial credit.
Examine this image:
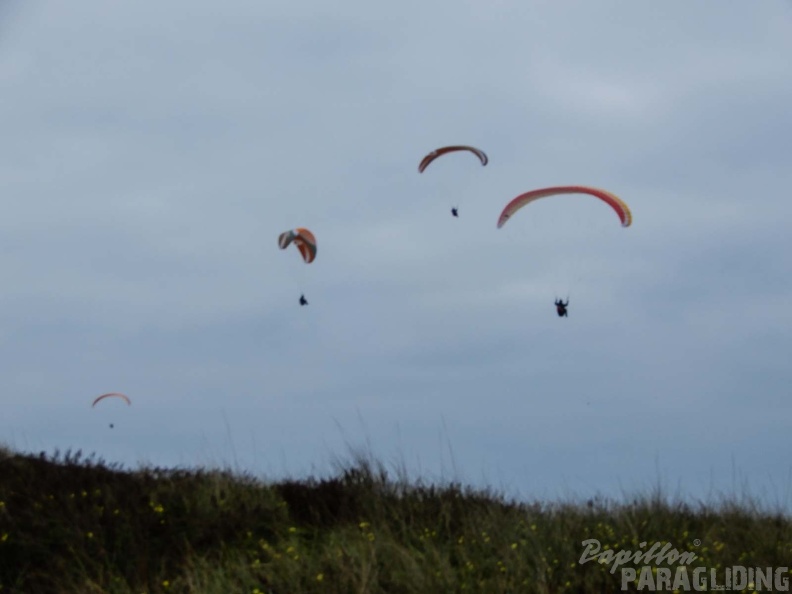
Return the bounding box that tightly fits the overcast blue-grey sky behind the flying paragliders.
[0,0,792,509]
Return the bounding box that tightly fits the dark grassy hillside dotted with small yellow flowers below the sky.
[0,449,792,594]
